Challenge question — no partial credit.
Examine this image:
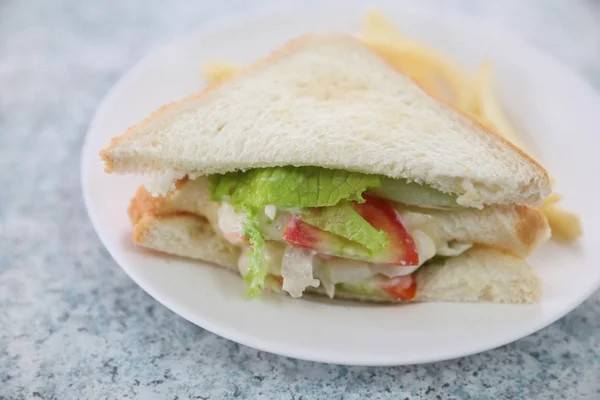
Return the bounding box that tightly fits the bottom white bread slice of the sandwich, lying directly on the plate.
[134,214,541,303]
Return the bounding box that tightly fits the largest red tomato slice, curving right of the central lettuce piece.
[354,194,419,266]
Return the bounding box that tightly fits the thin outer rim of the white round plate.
[80,5,600,366]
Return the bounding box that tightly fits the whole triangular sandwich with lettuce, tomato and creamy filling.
[101,33,550,303]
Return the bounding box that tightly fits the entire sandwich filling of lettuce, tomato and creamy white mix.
[208,166,472,300]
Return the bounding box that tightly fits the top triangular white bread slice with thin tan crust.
[101,33,550,207]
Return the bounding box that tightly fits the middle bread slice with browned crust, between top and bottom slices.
[129,177,550,257]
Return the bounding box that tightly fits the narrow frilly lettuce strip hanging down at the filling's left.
[243,207,269,297]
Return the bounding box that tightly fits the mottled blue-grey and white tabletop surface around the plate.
[0,0,600,400]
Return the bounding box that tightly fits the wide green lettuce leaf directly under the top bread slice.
[209,166,384,208]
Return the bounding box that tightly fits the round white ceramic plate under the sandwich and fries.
[81,5,600,365]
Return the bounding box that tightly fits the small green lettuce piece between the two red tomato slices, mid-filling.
[300,201,388,252]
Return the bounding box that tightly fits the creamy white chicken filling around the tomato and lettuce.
[217,202,472,297]
